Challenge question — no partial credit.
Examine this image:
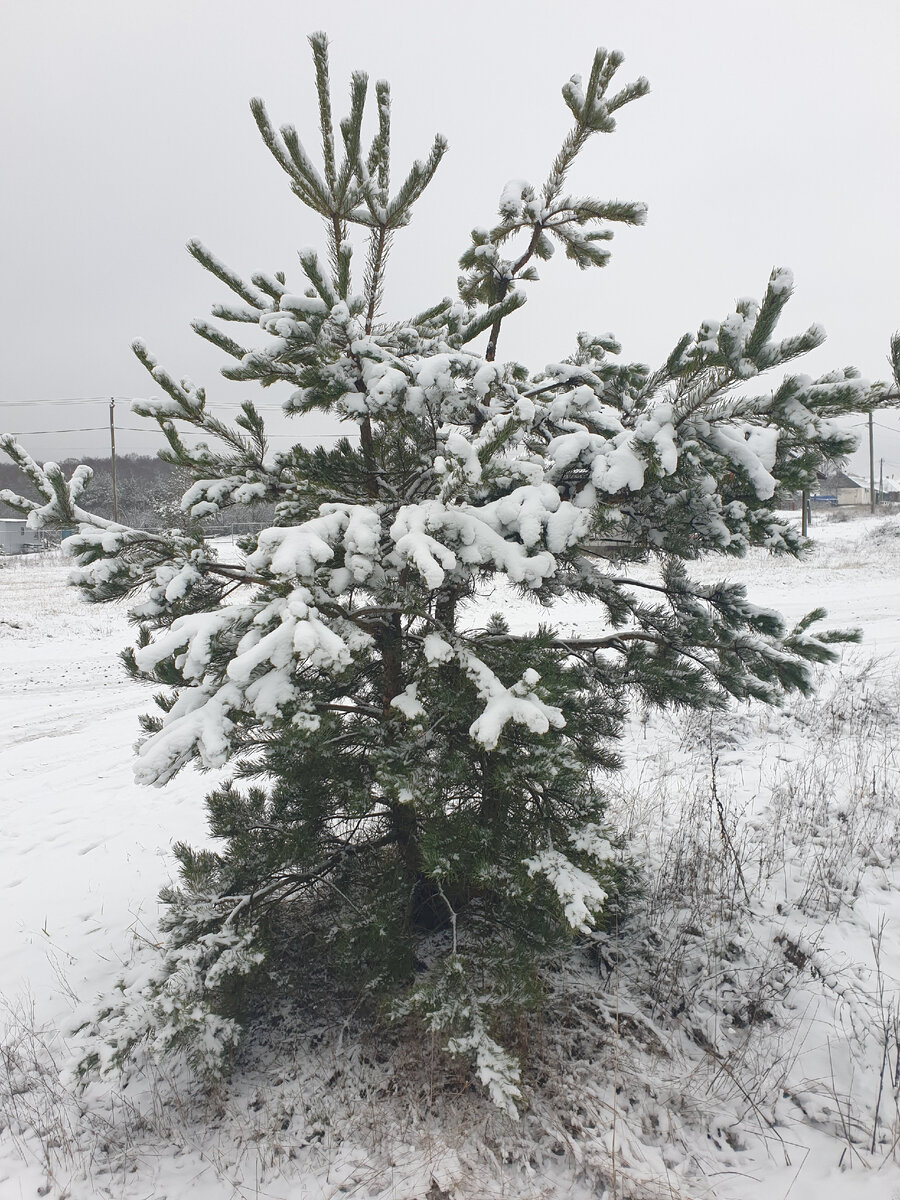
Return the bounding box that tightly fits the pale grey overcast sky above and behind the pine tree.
[0,0,900,475]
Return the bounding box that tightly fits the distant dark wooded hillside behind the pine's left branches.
[0,454,272,529]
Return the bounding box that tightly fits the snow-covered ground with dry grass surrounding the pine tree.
[0,517,900,1200]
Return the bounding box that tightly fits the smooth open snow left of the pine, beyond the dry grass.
[0,556,217,1021]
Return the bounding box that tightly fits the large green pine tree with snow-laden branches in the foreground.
[4,34,900,1111]
